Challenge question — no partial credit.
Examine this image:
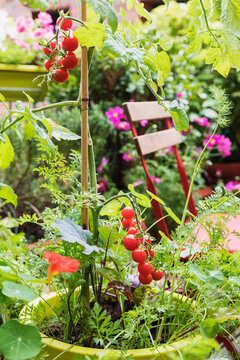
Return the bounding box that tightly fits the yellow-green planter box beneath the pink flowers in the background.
[0,64,47,102]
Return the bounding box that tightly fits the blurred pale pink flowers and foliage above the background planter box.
[0,10,54,64]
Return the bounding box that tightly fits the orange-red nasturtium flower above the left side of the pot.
[43,251,80,288]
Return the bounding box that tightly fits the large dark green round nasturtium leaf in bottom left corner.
[0,320,42,360]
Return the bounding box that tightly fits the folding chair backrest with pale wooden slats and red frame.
[123,101,197,237]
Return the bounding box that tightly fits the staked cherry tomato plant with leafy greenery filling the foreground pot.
[0,1,239,359]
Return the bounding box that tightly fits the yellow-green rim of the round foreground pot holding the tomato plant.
[19,291,202,360]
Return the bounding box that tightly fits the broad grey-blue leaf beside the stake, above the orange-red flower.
[53,218,100,255]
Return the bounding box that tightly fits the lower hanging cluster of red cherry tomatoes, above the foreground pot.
[122,207,163,284]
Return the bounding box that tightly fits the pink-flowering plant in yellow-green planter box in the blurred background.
[0,10,54,102]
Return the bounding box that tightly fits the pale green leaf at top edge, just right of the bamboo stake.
[87,0,118,32]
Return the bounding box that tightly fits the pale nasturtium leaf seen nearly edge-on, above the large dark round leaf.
[2,281,36,301]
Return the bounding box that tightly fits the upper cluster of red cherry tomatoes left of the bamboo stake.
[43,16,79,83]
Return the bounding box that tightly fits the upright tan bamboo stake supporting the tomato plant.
[81,1,89,229]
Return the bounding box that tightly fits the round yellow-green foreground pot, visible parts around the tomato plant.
[20,293,202,360]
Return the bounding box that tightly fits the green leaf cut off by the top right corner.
[221,0,240,37]
